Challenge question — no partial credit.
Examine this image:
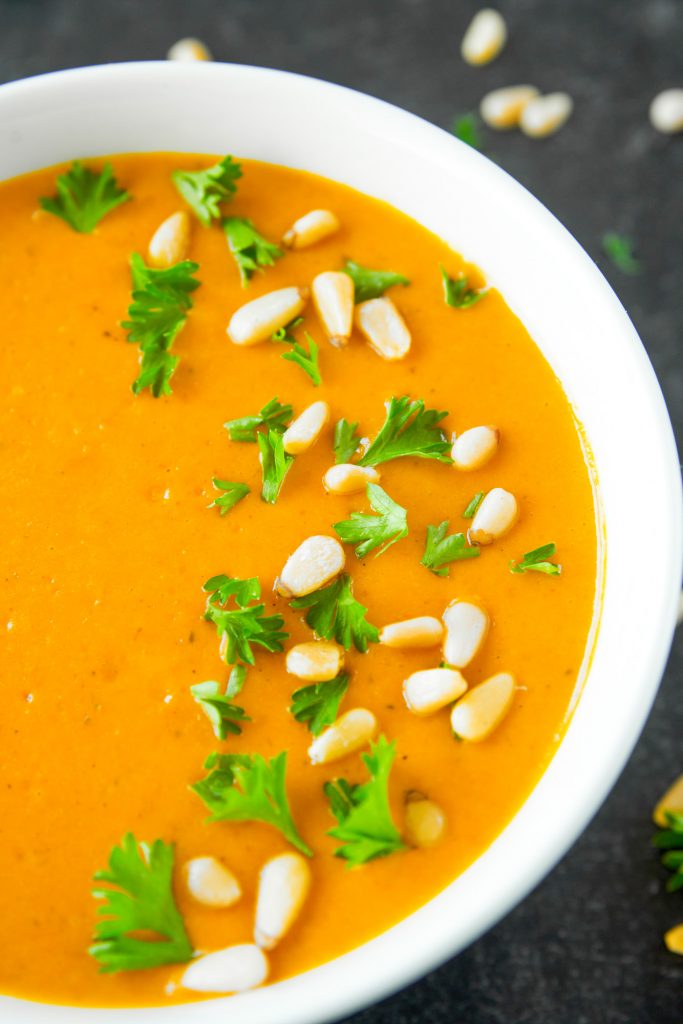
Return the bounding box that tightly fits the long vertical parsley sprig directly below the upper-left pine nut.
[121,253,200,398]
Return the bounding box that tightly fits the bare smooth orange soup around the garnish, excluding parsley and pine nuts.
[0,154,597,1007]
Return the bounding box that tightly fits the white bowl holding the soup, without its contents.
[0,63,681,1024]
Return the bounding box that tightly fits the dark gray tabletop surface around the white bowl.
[0,0,683,1024]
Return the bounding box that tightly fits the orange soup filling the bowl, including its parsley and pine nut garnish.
[0,155,597,1007]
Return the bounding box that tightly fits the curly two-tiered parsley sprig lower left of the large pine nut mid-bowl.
[203,575,289,665]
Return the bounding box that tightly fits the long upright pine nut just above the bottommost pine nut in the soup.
[254,853,310,949]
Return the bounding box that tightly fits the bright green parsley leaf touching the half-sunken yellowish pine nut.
[324,736,405,867]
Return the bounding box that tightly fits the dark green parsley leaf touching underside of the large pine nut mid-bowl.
[290,572,380,654]
